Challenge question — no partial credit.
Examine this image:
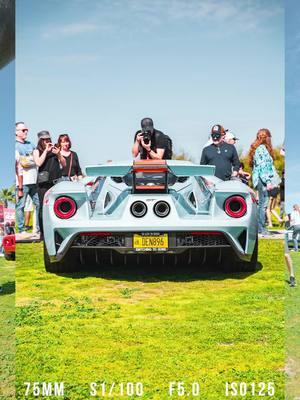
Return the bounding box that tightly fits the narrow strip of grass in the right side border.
[286,252,300,400]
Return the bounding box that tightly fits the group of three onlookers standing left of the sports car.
[16,122,82,240]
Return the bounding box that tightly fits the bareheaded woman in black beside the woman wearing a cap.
[57,134,82,181]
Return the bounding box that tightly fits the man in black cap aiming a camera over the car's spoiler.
[132,118,172,160]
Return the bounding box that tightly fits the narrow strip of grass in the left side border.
[0,257,15,400]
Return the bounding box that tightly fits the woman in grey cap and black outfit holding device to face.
[33,131,66,239]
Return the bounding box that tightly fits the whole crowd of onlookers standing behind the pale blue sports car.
[16,117,300,286]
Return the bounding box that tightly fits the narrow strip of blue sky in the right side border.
[285,0,300,212]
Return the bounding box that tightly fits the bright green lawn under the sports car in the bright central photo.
[16,240,285,400]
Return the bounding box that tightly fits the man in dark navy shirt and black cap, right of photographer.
[200,125,240,181]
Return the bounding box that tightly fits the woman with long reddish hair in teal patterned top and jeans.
[249,128,274,235]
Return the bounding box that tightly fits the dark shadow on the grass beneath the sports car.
[57,263,263,282]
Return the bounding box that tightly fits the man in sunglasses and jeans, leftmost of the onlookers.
[16,122,40,238]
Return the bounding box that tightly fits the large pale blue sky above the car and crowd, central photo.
[16,0,284,169]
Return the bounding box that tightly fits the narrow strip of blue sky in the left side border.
[0,62,15,188]
